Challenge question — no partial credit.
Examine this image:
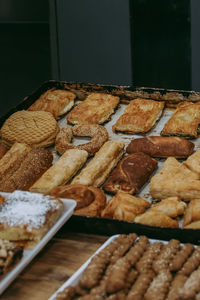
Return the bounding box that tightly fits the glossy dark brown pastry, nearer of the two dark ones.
[103,152,157,194]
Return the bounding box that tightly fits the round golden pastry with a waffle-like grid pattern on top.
[1,110,59,147]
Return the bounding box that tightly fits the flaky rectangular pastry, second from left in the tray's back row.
[67,93,120,125]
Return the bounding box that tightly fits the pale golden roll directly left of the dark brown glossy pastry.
[72,141,124,187]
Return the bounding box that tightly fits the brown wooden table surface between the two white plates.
[0,231,109,300]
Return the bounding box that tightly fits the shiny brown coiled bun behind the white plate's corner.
[49,184,106,217]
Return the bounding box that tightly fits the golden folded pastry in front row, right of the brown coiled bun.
[101,192,150,222]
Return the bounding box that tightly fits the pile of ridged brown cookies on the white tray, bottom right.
[55,233,200,300]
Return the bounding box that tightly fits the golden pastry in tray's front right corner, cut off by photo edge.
[183,199,200,226]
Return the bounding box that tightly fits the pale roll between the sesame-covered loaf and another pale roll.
[30,149,88,194]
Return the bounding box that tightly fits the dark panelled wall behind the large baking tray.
[0,0,200,115]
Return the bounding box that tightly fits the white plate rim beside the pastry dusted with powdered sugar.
[0,193,76,295]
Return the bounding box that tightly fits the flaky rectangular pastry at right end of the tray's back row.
[161,102,200,139]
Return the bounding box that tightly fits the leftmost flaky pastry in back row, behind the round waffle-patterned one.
[28,88,76,119]
